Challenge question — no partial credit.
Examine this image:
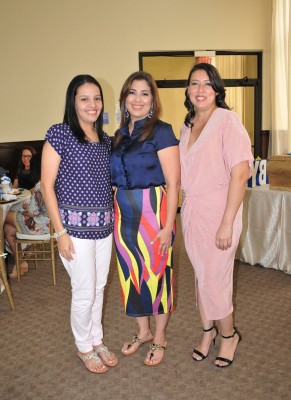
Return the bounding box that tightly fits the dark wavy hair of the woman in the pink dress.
[184,63,229,128]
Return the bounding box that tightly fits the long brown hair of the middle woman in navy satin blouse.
[115,71,162,146]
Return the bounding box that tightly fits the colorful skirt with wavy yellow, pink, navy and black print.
[114,187,175,317]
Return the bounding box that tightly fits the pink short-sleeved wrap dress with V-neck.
[179,108,253,320]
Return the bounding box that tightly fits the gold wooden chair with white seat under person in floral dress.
[15,223,57,286]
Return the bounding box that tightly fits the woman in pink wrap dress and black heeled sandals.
[180,63,253,368]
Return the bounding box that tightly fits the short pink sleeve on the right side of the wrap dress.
[223,111,254,175]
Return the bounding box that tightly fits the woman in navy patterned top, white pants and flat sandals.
[41,75,118,374]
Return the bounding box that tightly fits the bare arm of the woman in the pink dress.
[215,161,249,250]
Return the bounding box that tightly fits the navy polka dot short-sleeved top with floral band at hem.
[46,123,113,239]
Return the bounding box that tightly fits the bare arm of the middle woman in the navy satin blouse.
[153,146,181,255]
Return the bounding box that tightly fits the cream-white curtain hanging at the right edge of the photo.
[269,0,291,155]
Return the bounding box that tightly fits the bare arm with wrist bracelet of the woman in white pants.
[41,142,75,261]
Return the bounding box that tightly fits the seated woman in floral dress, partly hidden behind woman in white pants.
[4,154,49,278]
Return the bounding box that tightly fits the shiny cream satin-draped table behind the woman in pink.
[236,185,291,274]
